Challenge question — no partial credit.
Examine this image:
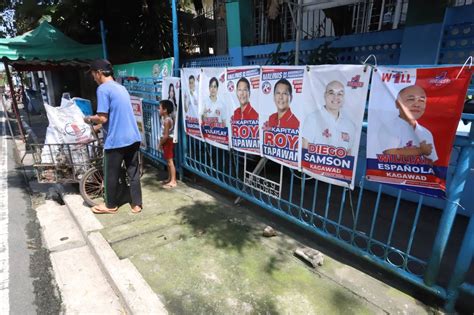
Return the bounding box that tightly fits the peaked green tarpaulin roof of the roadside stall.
[0,21,102,69]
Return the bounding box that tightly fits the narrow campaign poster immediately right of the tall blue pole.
[181,68,202,139]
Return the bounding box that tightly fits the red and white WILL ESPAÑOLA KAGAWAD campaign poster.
[366,67,471,198]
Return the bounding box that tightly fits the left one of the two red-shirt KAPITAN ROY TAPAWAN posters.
[226,66,260,154]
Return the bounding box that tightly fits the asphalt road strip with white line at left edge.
[0,111,61,314]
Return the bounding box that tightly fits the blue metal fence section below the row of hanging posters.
[182,113,474,308]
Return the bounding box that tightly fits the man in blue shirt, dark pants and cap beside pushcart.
[84,59,142,213]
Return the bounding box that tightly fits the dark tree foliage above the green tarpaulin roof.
[0,0,173,63]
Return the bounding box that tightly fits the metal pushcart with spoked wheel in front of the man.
[32,140,104,206]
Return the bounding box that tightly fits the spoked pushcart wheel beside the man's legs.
[79,167,104,207]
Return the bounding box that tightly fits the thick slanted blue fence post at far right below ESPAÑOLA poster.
[424,132,474,286]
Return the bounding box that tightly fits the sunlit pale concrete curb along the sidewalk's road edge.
[59,194,168,314]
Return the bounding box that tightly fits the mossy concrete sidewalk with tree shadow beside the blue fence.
[64,167,435,314]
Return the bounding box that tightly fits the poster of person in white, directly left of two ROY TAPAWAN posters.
[199,68,231,150]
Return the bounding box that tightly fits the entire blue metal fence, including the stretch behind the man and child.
[124,66,474,310]
